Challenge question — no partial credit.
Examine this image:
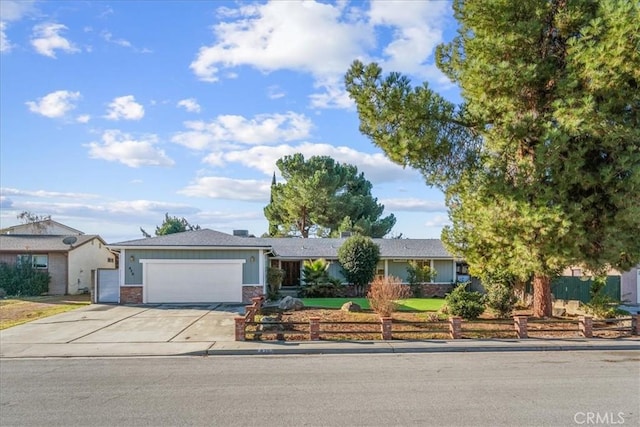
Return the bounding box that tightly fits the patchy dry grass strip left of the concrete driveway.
[0,295,91,330]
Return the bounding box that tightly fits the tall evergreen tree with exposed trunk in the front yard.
[346,0,640,316]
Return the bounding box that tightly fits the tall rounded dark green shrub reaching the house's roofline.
[338,235,380,295]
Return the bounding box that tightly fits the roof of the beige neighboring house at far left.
[0,234,104,252]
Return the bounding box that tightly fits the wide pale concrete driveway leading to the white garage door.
[0,304,244,357]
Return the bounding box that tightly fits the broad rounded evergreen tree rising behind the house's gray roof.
[264,153,396,238]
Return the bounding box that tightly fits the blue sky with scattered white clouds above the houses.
[0,0,459,243]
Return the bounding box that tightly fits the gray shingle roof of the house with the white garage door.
[109,229,452,259]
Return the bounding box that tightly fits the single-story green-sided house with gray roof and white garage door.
[109,229,459,303]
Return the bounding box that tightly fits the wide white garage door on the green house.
[140,259,245,303]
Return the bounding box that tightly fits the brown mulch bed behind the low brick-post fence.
[247,308,629,341]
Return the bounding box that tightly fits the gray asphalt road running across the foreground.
[0,351,640,426]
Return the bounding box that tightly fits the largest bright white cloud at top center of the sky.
[191,1,374,82]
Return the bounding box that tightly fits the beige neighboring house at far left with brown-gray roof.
[0,232,116,295]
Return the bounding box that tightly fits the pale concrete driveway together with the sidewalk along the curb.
[0,304,640,358]
